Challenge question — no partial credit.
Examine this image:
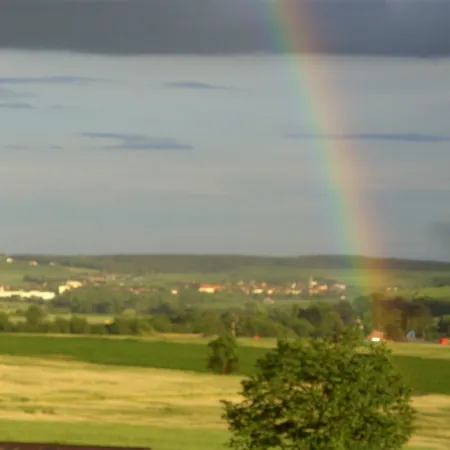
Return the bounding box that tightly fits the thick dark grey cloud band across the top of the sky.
[0,0,450,56]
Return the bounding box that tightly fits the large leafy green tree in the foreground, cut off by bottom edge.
[223,329,414,450]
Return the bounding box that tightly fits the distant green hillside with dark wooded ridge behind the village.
[5,255,450,292]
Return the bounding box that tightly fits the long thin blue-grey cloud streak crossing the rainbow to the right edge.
[286,133,450,143]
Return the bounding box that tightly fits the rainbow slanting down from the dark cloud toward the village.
[261,0,381,286]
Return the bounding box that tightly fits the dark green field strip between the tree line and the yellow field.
[0,334,450,395]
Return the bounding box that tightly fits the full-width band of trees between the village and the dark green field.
[0,294,450,340]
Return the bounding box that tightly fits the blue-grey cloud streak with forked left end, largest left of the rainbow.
[83,132,193,151]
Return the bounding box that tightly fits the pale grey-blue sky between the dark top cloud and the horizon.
[0,0,450,260]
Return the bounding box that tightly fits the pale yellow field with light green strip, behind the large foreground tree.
[0,356,450,450]
